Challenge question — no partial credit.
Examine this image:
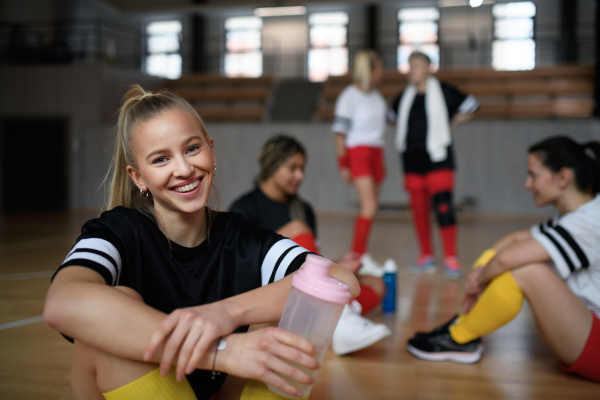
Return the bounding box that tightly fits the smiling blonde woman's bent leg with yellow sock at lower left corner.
[71,287,196,400]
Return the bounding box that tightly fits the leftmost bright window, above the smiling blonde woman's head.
[145,21,181,79]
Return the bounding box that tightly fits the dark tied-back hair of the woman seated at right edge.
[529,136,600,194]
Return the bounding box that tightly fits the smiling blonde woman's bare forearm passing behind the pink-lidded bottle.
[223,264,360,326]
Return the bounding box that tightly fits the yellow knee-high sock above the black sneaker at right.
[450,272,524,344]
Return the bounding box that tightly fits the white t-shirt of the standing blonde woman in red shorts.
[331,85,387,147]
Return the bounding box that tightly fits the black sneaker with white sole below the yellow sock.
[406,324,483,364]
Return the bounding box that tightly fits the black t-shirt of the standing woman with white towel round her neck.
[390,83,467,173]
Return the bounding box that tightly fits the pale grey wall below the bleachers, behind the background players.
[207,119,600,214]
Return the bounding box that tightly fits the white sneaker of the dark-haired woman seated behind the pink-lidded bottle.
[331,300,392,356]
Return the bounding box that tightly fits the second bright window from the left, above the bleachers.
[224,17,263,78]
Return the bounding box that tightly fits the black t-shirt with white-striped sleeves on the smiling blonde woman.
[55,207,308,400]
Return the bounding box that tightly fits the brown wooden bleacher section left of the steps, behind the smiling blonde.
[169,74,273,121]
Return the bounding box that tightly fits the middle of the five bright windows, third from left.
[308,12,348,82]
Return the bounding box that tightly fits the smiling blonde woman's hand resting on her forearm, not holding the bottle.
[144,301,238,381]
